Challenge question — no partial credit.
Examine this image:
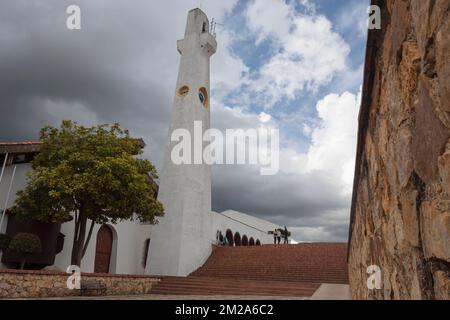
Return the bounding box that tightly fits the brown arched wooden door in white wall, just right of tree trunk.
[94,225,113,273]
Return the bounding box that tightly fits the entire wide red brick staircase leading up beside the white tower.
[152,243,348,297]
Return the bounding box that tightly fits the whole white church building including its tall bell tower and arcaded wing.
[0,9,280,276]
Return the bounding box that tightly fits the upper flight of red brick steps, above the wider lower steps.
[192,243,348,284]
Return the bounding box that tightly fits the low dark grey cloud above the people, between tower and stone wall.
[213,166,350,241]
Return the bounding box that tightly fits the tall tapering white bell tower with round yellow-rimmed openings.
[146,9,217,276]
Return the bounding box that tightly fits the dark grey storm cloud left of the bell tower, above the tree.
[0,0,184,162]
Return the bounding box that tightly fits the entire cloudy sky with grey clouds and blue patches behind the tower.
[0,0,369,241]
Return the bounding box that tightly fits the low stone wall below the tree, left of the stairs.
[0,269,160,299]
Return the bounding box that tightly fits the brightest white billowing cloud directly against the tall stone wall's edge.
[280,92,361,194]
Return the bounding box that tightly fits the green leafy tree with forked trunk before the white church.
[13,121,164,266]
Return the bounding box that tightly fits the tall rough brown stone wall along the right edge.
[349,0,450,299]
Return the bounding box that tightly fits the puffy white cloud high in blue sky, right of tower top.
[246,0,350,108]
